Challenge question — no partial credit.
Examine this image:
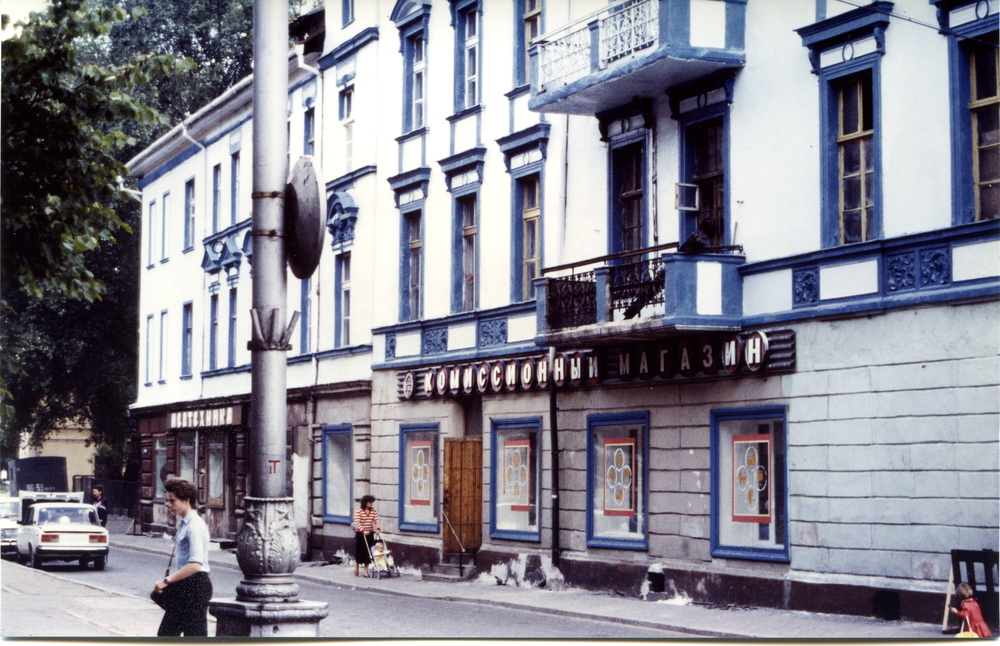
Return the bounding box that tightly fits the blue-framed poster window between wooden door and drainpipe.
[490,417,542,543]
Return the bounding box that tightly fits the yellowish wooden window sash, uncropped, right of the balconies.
[837,73,876,244]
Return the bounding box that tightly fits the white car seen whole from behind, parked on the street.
[17,502,109,570]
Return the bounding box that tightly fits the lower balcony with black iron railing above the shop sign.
[535,244,745,347]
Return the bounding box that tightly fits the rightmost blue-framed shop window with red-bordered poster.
[711,406,788,561]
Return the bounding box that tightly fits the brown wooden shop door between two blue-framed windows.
[444,437,483,554]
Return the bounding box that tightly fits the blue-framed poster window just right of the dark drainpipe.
[587,412,649,550]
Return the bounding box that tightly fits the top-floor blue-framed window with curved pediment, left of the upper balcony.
[391,0,431,133]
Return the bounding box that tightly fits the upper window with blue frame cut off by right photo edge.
[933,0,1000,225]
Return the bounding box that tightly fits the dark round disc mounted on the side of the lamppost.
[285,155,326,279]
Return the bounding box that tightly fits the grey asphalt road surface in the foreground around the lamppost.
[0,549,690,640]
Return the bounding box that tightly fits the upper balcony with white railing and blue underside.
[529,0,746,115]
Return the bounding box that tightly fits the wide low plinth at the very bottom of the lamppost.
[208,599,330,637]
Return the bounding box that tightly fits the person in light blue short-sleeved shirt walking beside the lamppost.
[154,478,212,637]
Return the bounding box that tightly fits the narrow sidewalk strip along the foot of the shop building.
[99,533,952,640]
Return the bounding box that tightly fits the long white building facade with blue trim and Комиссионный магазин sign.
[133,0,1000,620]
